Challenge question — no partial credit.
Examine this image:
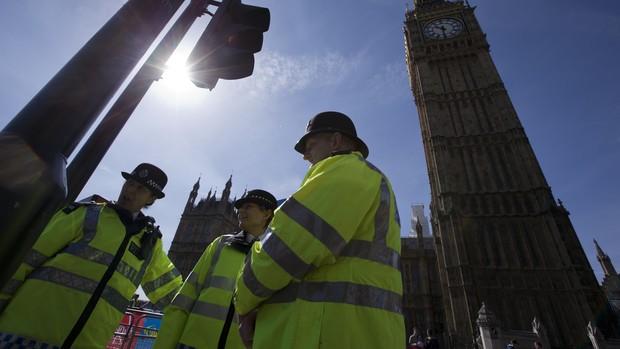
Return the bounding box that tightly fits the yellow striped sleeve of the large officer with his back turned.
[235,154,382,315]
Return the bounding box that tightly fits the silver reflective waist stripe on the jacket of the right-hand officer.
[265,282,402,314]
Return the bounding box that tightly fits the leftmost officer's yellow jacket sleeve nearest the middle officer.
[141,239,183,310]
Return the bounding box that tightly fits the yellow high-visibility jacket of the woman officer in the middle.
[153,232,250,349]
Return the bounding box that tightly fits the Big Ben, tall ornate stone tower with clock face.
[404,0,617,348]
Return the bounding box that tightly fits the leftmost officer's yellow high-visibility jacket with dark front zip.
[0,197,182,349]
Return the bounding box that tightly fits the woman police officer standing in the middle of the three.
[154,189,277,349]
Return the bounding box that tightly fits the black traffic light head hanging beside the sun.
[186,0,270,90]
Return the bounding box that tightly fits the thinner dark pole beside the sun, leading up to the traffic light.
[61,0,208,206]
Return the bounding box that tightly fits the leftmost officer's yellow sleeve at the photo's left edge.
[0,207,86,312]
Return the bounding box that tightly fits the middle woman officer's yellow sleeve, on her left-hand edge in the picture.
[153,235,219,349]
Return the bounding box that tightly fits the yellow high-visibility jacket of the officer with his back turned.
[235,152,406,349]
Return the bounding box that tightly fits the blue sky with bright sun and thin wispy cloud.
[0,0,620,281]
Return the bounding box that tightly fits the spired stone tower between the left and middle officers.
[168,176,239,279]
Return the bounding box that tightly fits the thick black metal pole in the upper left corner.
[0,0,184,288]
